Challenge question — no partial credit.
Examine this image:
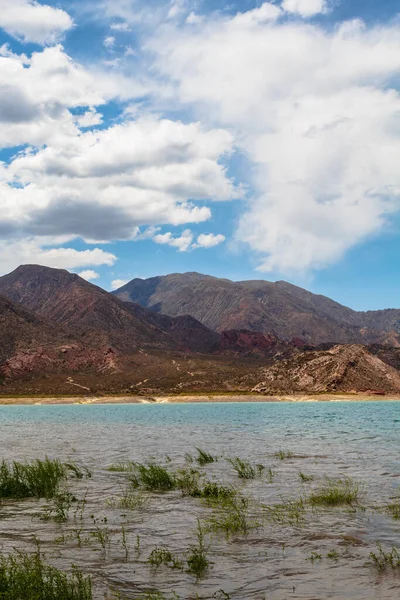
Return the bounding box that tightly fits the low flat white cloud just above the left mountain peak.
[0,237,117,274]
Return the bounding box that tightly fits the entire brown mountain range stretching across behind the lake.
[0,265,400,395]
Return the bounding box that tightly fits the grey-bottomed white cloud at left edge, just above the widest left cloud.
[0,42,158,148]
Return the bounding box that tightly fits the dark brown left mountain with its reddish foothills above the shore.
[0,265,292,392]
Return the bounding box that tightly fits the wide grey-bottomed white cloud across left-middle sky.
[0,117,240,241]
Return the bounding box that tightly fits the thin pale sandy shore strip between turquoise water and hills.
[0,394,400,406]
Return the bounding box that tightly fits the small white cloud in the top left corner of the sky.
[0,0,73,45]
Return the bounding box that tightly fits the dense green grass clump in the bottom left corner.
[0,551,92,600]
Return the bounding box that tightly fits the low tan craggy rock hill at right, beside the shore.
[253,344,400,394]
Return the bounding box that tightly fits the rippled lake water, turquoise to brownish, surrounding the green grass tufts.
[0,402,400,600]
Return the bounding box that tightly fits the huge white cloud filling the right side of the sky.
[149,1,400,273]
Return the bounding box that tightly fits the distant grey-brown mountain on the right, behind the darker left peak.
[114,273,400,346]
